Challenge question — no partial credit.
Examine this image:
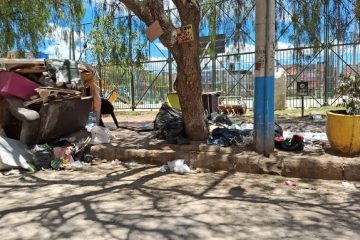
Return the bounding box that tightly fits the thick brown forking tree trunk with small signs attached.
[120,0,208,140]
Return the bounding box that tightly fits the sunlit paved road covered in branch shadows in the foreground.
[0,163,360,240]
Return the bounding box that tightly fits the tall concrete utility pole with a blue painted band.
[254,0,275,156]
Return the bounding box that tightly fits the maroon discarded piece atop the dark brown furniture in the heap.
[0,72,40,101]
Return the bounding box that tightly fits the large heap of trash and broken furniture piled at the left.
[0,58,105,171]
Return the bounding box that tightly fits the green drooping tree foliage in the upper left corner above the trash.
[0,0,84,55]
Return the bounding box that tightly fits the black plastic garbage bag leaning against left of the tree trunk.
[154,103,189,144]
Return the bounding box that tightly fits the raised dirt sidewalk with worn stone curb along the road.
[90,126,360,181]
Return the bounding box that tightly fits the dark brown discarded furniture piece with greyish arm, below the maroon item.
[2,97,92,145]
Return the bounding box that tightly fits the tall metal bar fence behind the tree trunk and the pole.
[87,0,359,110]
